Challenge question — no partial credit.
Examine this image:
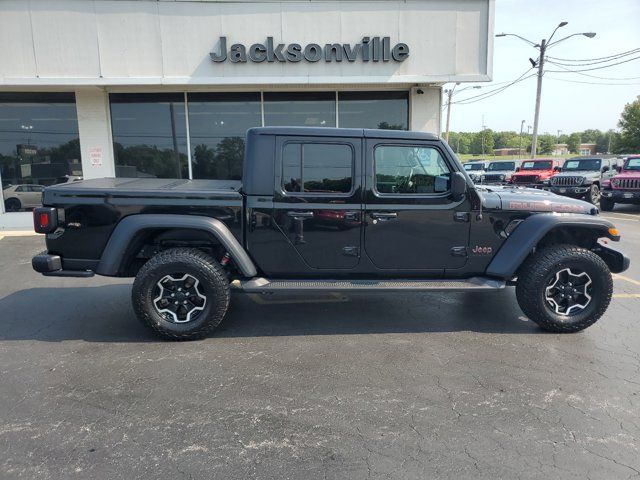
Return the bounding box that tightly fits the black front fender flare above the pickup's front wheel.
[486,213,620,279]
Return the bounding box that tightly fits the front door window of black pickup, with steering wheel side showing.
[374,145,451,194]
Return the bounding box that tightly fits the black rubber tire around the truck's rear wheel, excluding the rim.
[131,248,230,341]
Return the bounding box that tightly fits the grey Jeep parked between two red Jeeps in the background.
[550,157,616,205]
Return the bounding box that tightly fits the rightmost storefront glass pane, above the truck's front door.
[338,92,409,130]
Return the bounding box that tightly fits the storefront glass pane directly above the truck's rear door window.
[264,92,336,127]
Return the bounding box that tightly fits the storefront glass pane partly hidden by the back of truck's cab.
[188,93,262,180]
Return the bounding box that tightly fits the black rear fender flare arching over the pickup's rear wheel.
[96,214,258,277]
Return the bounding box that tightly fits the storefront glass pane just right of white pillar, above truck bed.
[109,93,189,178]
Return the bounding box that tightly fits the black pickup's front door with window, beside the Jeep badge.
[364,139,471,274]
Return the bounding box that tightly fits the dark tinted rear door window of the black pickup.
[282,143,354,194]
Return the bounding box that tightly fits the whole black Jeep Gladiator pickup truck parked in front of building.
[32,127,629,340]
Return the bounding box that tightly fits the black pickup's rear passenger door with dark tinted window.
[273,137,362,270]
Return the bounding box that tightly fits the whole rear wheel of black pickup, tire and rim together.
[131,248,230,340]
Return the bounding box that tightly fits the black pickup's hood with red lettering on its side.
[476,185,598,215]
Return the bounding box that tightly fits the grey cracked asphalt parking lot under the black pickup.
[0,206,640,479]
